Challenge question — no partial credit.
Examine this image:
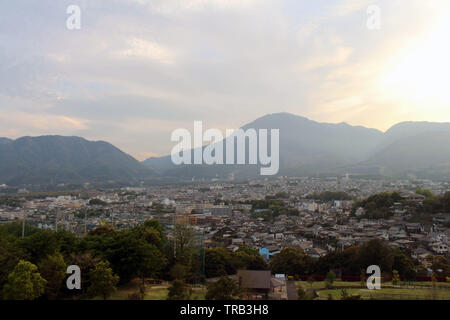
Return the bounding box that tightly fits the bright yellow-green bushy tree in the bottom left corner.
[3,260,47,300]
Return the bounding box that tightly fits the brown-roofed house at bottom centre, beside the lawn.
[237,270,272,300]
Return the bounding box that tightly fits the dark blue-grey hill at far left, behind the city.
[0,136,152,185]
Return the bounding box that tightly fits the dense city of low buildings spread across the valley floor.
[0,175,450,299]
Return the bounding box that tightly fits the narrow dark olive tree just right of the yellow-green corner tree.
[39,252,67,300]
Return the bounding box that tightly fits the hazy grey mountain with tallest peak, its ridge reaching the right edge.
[143,113,450,178]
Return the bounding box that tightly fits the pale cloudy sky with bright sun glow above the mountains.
[0,0,450,160]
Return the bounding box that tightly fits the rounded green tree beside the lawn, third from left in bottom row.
[88,261,119,300]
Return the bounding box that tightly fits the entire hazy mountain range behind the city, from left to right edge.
[0,113,450,185]
